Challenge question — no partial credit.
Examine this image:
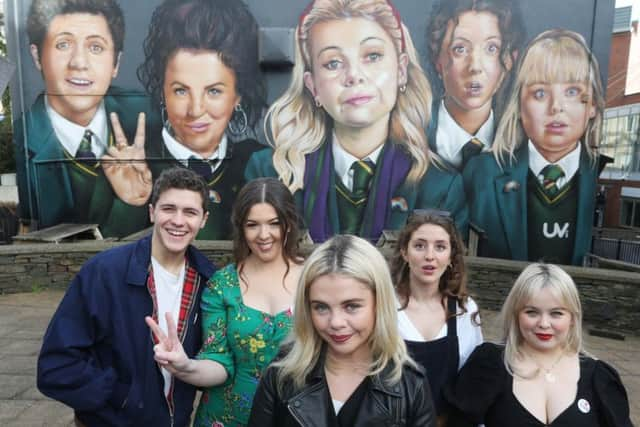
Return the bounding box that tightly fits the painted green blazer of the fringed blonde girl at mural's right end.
[463,144,597,265]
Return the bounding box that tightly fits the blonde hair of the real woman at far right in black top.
[500,263,583,374]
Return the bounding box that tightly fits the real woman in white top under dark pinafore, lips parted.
[391,211,482,425]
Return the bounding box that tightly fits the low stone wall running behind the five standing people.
[0,242,640,335]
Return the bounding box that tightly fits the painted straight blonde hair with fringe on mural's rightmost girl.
[492,29,604,166]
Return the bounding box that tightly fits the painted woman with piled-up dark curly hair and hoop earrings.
[138,0,265,239]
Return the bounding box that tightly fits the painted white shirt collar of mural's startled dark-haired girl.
[427,100,495,172]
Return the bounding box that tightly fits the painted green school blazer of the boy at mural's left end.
[13,87,156,237]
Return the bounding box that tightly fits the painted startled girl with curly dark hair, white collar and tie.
[427,0,523,171]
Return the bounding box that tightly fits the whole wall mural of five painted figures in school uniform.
[6,0,613,264]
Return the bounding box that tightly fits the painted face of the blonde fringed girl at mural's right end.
[520,83,596,163]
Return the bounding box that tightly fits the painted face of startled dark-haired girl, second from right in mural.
[436,11,511,123]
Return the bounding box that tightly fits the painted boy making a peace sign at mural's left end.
[14,0,152,236]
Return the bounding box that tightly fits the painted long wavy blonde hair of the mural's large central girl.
[265,0,432,192]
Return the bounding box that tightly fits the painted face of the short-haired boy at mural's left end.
[31,13,120,126]
